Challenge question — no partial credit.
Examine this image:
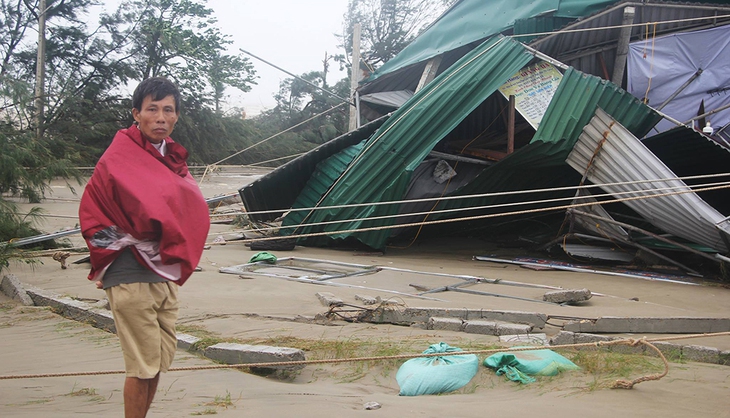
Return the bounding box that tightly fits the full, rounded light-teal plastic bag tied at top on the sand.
[395,342,479,396]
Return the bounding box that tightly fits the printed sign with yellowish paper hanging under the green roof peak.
[499,61,563,129]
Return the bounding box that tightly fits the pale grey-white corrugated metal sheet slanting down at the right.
[566,109,730,252]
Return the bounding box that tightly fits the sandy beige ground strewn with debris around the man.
[0,171,730,417]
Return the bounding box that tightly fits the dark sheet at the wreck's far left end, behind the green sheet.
[238,116,388,222]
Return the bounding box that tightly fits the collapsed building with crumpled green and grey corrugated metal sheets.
[240,0,730,280]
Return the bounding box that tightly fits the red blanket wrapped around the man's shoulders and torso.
[79,126,210,285]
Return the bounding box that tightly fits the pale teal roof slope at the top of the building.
[368,0,616,82]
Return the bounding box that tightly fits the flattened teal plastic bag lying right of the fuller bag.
[484,350,580,383]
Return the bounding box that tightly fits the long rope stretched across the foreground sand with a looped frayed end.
[0,332,730,389]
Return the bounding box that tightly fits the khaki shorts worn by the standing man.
[106,282,179,379]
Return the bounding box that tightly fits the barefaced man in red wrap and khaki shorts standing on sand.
[79,77,210,418]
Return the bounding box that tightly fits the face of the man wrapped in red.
[132,95,178,144]
